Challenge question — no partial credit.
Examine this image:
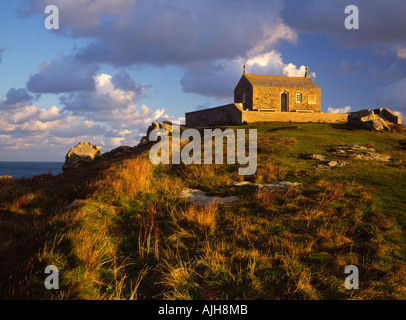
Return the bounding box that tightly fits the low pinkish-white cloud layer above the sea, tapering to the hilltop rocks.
[0,100,147,161]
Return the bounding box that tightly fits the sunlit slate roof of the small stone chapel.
[244,74,320,90]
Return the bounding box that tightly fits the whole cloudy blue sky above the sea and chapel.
[0,0,406,162]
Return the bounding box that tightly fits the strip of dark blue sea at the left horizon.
[0,161,64,179]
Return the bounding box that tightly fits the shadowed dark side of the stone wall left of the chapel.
[185,103,243,127]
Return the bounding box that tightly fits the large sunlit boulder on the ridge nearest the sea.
[62,142,102,170]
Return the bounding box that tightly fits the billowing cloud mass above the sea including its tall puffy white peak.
[0,72,184,161]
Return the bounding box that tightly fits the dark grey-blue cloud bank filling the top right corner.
[281,0,406,47]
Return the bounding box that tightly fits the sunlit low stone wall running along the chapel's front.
[242,111,348,123]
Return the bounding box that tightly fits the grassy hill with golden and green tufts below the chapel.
[0,123,406,299]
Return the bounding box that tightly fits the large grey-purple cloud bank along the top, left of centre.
[25,0,296,67]
